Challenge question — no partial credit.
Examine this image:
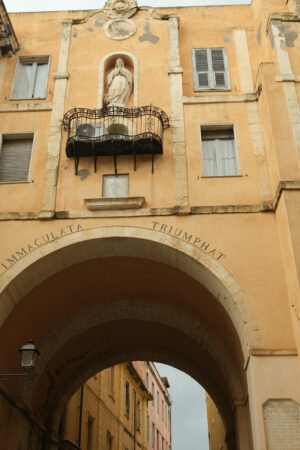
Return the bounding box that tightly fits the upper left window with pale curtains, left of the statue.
[11,56,50,100]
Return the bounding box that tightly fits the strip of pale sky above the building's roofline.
[4,0,251,12]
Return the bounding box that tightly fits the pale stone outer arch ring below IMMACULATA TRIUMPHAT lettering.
[0,226,262,361]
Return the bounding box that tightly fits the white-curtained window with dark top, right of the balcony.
[201,125,240,177]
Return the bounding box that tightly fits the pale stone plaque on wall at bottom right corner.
[264,400,300,450]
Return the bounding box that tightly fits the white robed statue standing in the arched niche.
[105,58,133,107]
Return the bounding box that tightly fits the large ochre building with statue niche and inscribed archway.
[0,0,300,450]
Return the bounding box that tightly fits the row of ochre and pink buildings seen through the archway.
[59,361,172,450]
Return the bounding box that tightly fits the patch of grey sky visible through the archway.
[155,363,209,450]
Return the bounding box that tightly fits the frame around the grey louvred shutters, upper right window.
[192,47,231,92]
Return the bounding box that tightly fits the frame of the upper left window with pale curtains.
[10,55,51,101]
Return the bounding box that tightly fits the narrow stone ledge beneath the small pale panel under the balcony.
[84,197,145,211]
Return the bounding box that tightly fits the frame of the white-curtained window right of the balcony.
[199,124,242,178]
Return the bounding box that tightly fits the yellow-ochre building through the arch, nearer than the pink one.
[59,361,162,450]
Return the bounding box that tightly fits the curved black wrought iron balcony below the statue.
[63,105,170,175]
